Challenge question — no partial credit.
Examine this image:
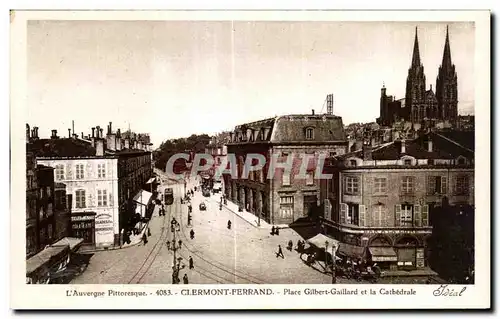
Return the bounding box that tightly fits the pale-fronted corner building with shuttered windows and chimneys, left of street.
[26,122,152,250]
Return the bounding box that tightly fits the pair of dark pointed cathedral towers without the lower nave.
[405,27,458,123]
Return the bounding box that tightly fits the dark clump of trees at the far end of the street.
[153,134,211,174]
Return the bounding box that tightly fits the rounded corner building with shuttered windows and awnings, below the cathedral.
[321,131,474,269]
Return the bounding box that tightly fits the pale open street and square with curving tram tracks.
[71,180,360,284]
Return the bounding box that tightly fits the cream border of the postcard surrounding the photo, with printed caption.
[10,11,491,309]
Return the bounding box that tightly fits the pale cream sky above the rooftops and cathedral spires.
[27,21,475,147]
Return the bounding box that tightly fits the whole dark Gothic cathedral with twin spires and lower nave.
[377,27,458,128]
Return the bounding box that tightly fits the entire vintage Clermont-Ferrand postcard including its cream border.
[10,11,491,309]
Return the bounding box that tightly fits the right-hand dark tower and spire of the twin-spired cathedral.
[436,26,458,122]
